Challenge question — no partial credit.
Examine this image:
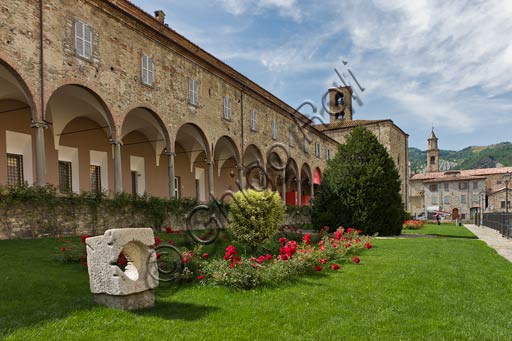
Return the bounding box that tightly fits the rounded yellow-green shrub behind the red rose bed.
[229,190,285,249]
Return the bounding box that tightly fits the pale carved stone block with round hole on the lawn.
[86,228,158,309]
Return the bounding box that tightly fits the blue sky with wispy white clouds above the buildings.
[132,0,512,150]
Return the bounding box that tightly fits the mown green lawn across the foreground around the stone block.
[0,232,512,340]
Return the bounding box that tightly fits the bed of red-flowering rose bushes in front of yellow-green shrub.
[197,227,372,289]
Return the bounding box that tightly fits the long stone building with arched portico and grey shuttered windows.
[0,0,407,205]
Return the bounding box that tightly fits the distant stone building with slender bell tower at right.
[409,130,512,221]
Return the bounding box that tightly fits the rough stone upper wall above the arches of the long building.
[0,0,337,191]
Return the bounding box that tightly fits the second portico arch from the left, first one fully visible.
[45,84,118,192]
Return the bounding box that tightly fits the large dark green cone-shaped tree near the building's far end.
[312,126,405,235]
